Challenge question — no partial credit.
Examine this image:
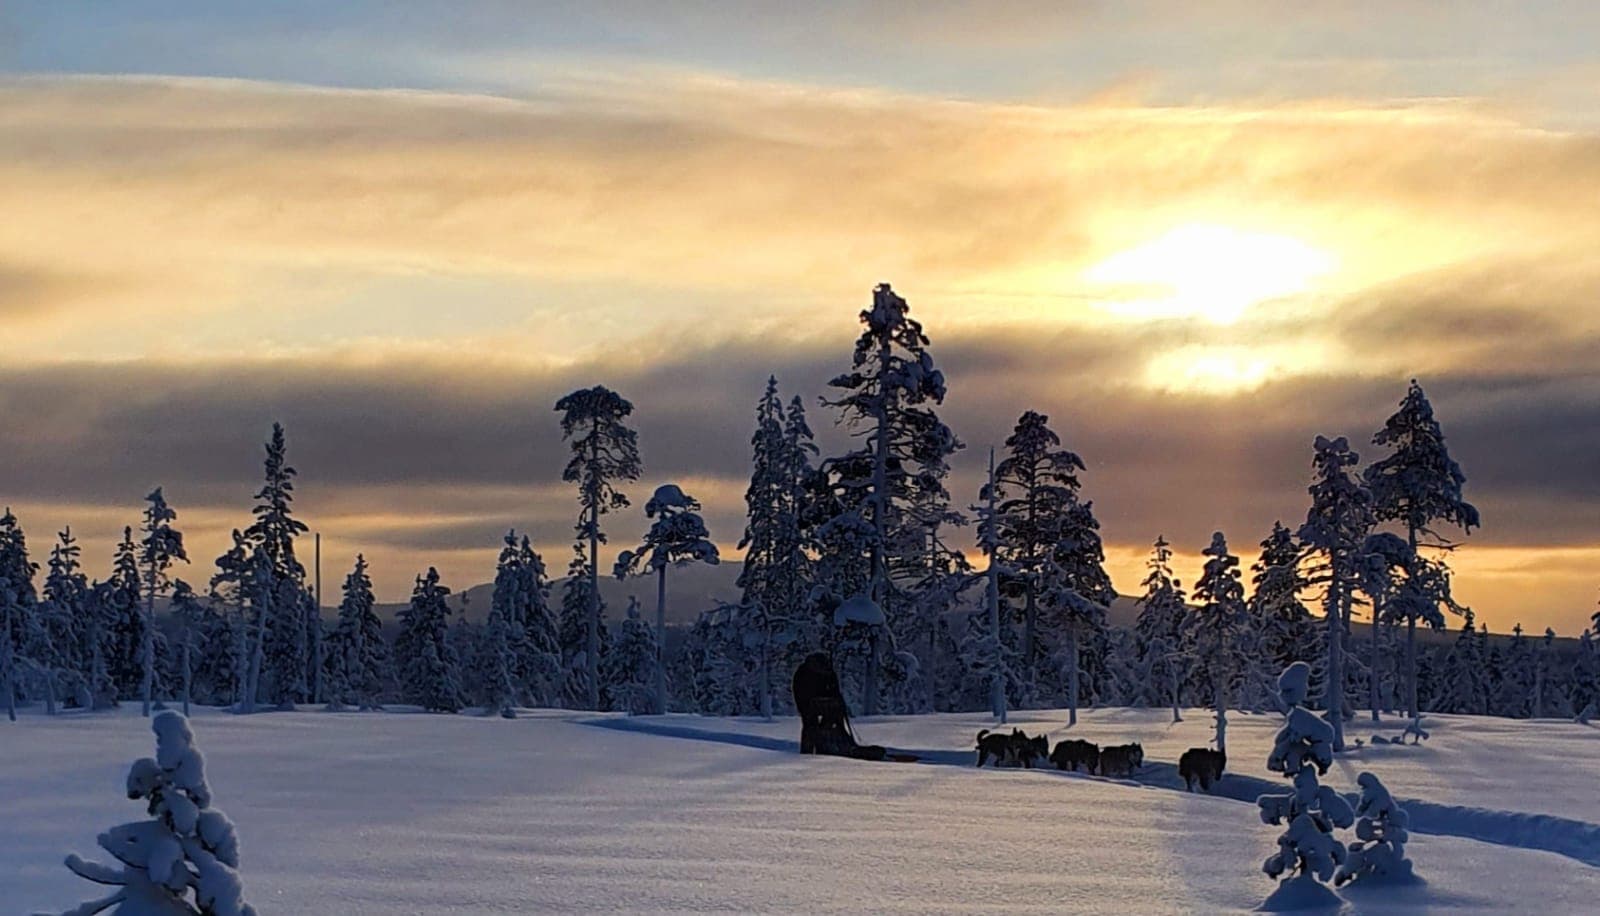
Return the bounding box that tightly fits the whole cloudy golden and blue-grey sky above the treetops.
[0,0,1600,634]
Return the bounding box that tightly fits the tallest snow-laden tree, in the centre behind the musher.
[818,283,962,716]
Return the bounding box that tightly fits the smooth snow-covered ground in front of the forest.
[0,709,1600,916]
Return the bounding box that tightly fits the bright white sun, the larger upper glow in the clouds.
[1083,223,1336,325]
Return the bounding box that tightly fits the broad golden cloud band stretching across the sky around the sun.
[0,75,1600,356]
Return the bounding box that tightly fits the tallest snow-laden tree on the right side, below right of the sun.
[1365,380,1480,716]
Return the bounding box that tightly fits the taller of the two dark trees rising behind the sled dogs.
[995,410,1083,679]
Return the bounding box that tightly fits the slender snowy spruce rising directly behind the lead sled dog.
[1184,532,1250,754]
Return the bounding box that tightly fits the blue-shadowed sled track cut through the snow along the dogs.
[579,719,1600,868]
